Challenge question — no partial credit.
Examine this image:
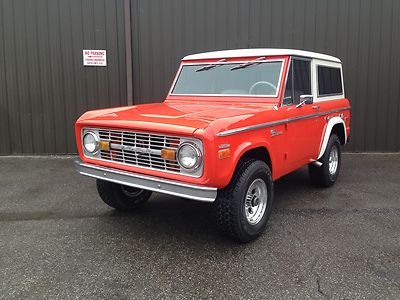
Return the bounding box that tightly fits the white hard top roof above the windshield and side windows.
[182,48,341,63]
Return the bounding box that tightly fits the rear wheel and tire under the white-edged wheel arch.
[308,134,342,187]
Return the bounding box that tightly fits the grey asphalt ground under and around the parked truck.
[0,154,400,299]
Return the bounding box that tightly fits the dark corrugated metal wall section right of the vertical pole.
[132,0,400,151]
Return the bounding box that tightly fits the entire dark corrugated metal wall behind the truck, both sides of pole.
[0,0,400,154]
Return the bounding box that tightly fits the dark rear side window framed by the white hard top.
[318,66,343,96]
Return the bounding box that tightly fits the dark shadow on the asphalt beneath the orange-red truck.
[93,169,315,247]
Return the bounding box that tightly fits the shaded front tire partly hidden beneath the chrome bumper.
[96,179,152,211]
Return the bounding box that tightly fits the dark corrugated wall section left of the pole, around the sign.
[0,0,126,154]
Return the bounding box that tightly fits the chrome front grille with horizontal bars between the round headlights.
[98,129,181,173]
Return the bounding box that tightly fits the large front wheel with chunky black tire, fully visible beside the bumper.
[215,159,273,243]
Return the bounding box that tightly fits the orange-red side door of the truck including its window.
[282,58,321,171]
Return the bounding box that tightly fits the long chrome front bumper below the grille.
[75,160,217,202]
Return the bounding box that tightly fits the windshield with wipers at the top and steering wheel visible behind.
[171,61,282,97]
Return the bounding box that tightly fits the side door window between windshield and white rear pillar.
[282,59,311,105]
